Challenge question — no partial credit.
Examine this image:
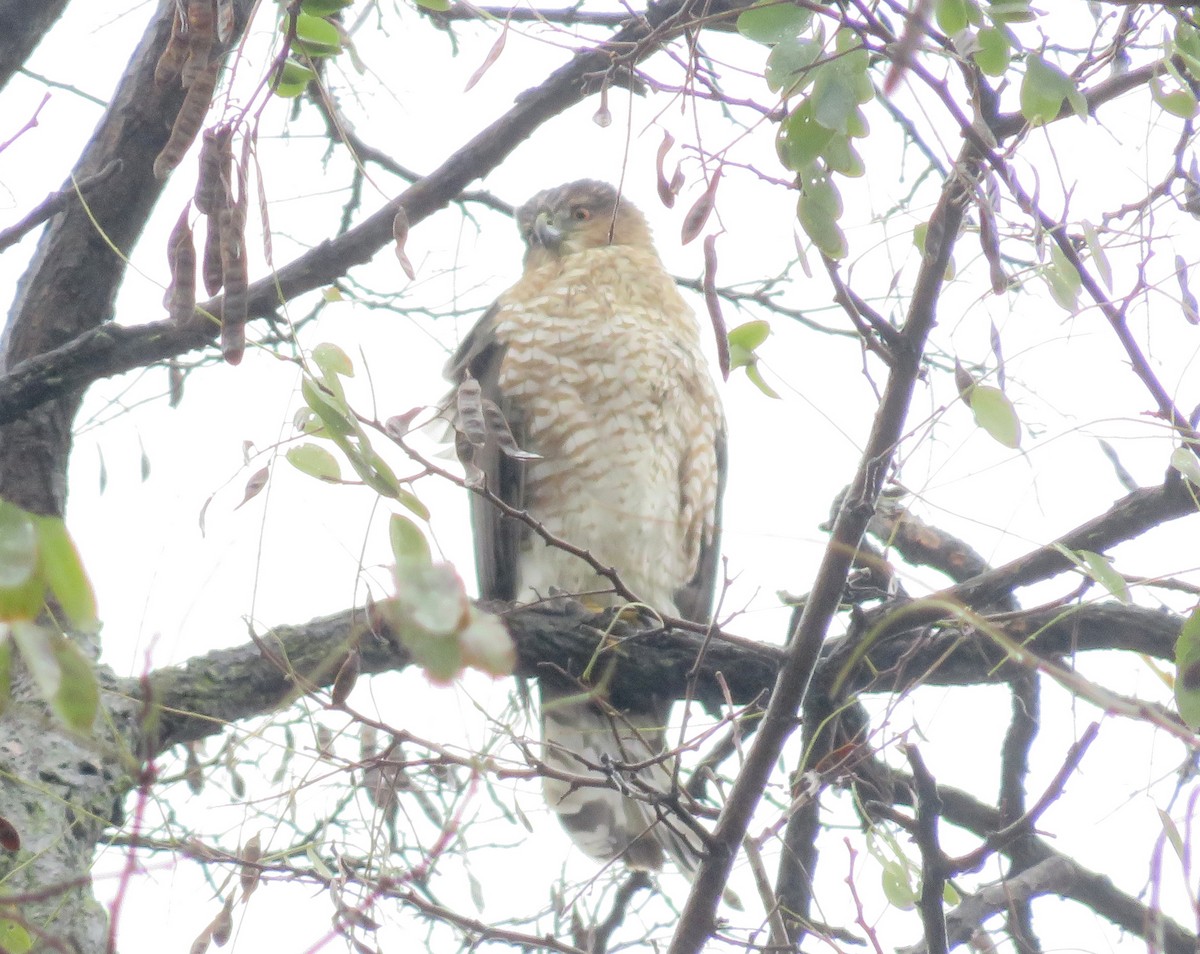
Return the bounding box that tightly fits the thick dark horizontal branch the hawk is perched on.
[145,590,1183,751]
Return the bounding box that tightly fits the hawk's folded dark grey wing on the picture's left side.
[445,304,528,601]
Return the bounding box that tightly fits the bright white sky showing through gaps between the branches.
[0,4,1200,954]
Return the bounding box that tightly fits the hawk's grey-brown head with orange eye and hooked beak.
[517,179,650,268]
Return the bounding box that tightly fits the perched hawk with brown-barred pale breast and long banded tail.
[446,180,725,872]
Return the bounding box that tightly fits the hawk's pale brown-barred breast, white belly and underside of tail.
[496,246,721,872]
